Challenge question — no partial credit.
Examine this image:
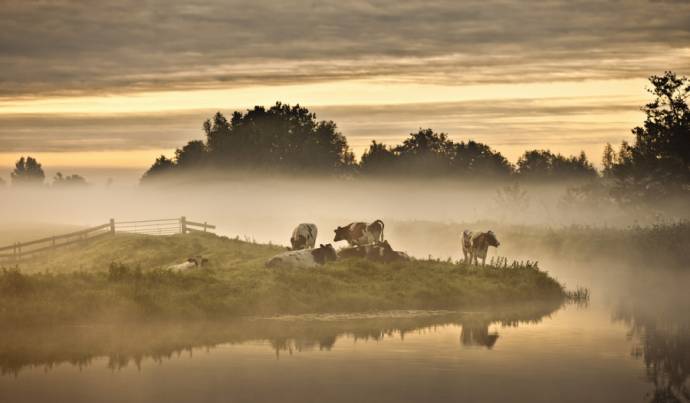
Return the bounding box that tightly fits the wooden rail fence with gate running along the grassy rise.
[0,217,216,263]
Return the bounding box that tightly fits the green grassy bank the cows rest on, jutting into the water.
[0,234,565,325]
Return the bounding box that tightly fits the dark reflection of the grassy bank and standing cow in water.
[0,304,559,376]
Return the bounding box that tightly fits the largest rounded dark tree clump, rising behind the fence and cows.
[145,102,355,178]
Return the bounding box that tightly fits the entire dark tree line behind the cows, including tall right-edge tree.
[142,71,690,200]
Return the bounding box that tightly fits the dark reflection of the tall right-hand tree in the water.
[613,304,690,403]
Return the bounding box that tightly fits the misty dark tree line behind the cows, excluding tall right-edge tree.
[142,102,597,183]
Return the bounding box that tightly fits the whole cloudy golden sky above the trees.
[0,0,690,182]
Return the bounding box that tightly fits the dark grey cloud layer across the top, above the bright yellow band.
[0,0,690,97]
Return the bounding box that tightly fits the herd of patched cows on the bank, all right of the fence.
[266,220,500,268]
